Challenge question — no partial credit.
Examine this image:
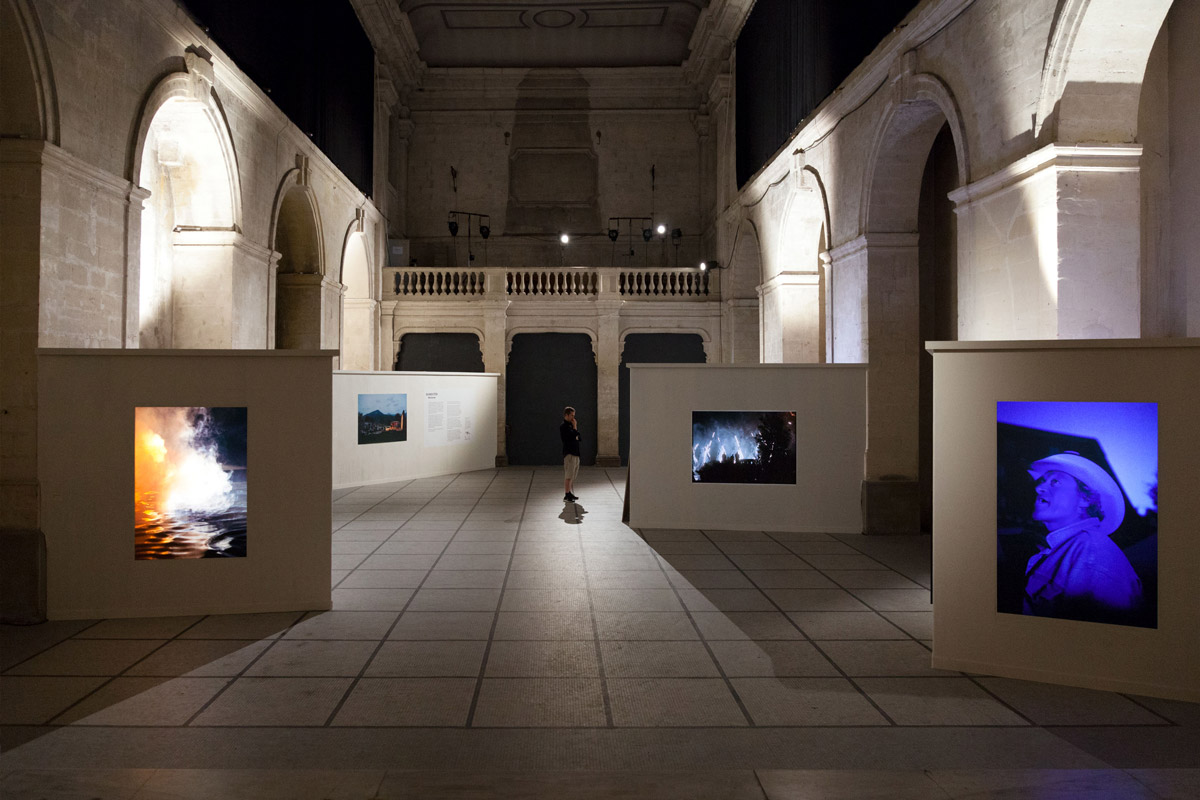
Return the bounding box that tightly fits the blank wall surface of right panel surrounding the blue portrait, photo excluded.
[928,339,1200,702]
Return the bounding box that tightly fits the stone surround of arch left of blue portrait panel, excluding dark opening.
[859,73,970,533]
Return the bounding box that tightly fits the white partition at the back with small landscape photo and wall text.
[332,371,499,488]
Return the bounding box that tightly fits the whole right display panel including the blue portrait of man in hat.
[928,339,1200,702]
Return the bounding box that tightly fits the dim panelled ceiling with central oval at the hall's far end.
[396,0,709,67]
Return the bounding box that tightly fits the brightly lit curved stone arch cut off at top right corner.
[1034,0,1171,143]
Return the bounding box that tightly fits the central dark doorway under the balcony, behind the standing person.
[504,333,596,465]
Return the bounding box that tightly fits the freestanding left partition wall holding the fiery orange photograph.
[37,349,337,619]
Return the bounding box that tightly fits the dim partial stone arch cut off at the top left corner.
[0,0,60,144]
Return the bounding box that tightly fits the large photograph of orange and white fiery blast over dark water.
[133,407,247,560]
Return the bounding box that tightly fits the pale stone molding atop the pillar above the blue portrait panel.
[949,144,1141,212]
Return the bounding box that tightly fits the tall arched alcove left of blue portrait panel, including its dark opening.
[863,76,968,533]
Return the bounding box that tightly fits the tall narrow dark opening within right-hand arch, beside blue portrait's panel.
[917,125,959,531]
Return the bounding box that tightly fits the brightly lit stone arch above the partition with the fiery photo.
[130,50,251,348]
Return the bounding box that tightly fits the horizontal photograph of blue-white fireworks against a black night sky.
[691,411,796,485]
